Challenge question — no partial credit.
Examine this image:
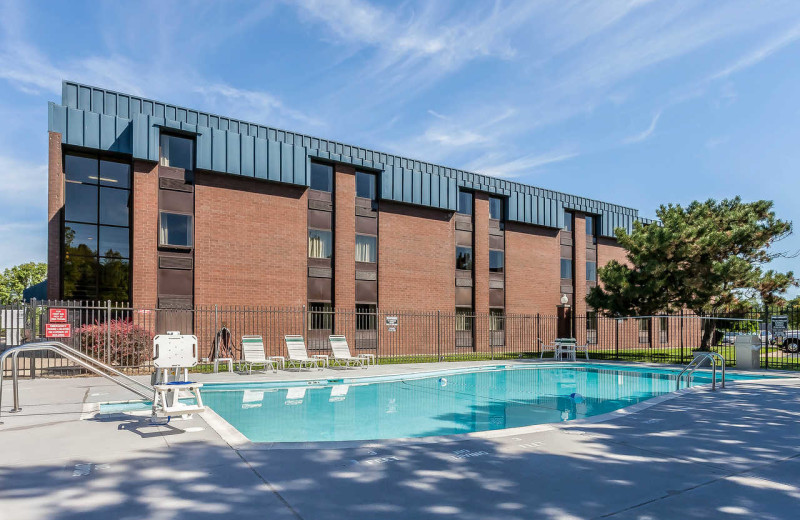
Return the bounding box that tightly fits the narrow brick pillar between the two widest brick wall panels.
[333,164,356,310]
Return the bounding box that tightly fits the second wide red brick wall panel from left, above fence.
[378,201,456,312]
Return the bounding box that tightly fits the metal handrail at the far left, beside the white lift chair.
[0,341,153,422]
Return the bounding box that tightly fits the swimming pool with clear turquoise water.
[197,364,758,442]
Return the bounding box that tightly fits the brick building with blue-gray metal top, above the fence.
[48,82,639,338]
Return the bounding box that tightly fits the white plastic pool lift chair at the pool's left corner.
[153,332,205,419]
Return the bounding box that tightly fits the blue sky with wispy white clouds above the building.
[0,0,800,292]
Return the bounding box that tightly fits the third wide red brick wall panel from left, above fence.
[505,222,561,316]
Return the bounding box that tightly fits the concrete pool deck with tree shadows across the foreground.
[0,362,800,520]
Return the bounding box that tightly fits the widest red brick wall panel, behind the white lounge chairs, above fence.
[192,173,308,307]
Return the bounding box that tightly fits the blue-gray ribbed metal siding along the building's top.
[49,81,645,236]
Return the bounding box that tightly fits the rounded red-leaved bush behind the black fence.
[77,320,153,367]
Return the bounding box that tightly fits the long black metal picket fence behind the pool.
[0,301,800,377]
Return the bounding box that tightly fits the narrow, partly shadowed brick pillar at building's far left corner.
[47,132,64,300]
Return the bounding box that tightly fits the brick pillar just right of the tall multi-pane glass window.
[131,161,158,309]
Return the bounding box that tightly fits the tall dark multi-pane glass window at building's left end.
[62,154,131,302]
